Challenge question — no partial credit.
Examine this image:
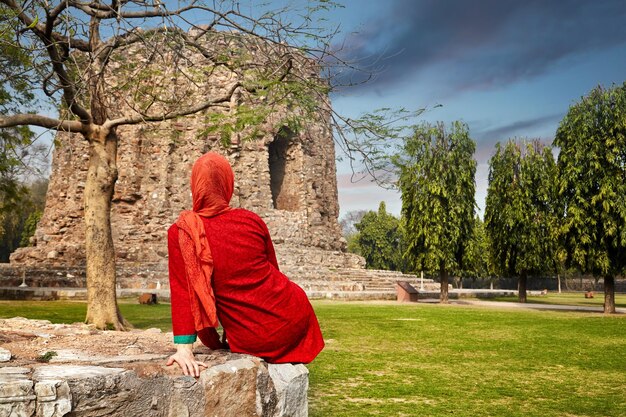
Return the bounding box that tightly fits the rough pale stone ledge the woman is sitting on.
[0,318,308,417]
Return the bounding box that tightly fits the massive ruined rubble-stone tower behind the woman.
[11,30,363,274]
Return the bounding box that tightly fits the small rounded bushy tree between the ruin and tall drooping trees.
[355,201,406,271]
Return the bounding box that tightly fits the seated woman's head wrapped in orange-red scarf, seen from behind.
[191,152,235,217]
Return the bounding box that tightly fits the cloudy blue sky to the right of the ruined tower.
[329,0,626,217]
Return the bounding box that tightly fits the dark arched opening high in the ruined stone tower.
[268,128,302,211]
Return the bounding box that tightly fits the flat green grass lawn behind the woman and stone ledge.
[0,301,626,417]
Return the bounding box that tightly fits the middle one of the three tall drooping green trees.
[485,140,558,302]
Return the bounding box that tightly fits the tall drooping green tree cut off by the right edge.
[554,83,626,313]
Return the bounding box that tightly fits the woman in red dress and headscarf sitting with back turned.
[167,152,324,376]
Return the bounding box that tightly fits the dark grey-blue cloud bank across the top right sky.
[338,0,626,93]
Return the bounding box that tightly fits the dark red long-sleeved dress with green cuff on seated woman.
[168,209,324,363]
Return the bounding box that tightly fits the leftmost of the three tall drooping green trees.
[392,122,476,303]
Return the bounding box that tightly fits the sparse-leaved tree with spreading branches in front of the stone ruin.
[0,0,410,329]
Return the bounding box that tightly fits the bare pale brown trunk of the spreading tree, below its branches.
[84,126,130,330]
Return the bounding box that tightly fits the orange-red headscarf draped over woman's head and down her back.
[176,152,235,331]
